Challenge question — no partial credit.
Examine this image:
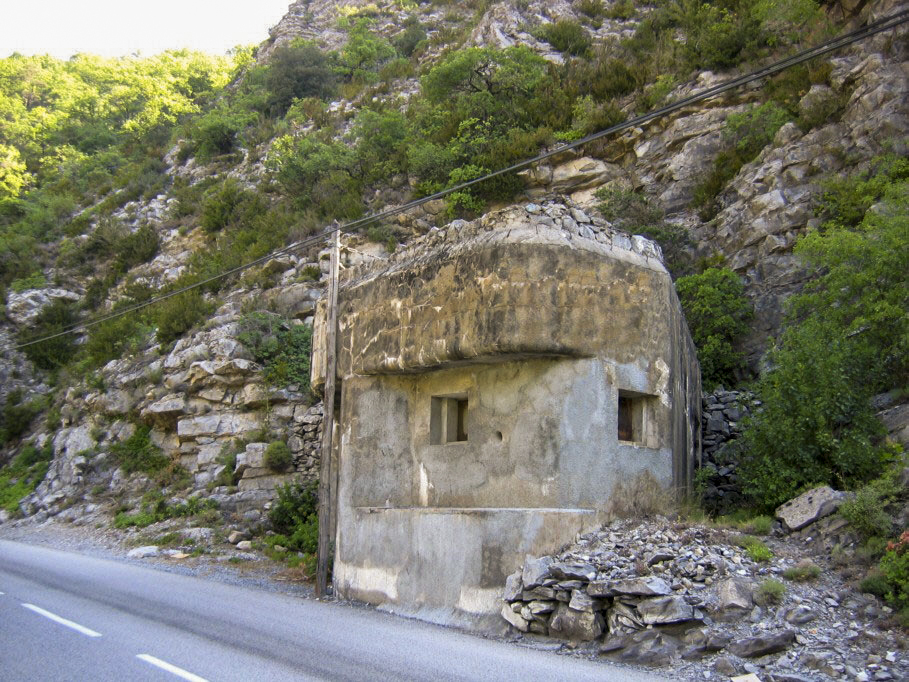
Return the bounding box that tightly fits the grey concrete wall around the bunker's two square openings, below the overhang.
[341,358,672,509]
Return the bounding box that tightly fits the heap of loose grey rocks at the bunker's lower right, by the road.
[502,504,909,681]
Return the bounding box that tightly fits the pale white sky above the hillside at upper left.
[0,0,291,59]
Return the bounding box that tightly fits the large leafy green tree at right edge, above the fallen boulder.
[741,159,909,507]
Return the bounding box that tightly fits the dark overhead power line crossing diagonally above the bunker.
[4,10,909,352]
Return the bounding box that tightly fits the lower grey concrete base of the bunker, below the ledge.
[332,507,604,629]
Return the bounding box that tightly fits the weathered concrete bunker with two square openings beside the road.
[313,203,700,627]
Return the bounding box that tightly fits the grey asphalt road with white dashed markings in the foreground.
[0,541,666,682]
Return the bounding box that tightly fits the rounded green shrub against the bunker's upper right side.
[675,268,753,388]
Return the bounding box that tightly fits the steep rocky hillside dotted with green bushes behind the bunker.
[0,0,909,612]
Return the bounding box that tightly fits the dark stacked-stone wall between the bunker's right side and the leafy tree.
[701,387,761,513]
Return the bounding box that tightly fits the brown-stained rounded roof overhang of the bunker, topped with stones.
[314,204,678,379]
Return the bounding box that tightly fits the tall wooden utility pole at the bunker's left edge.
[316,230,341,597]
